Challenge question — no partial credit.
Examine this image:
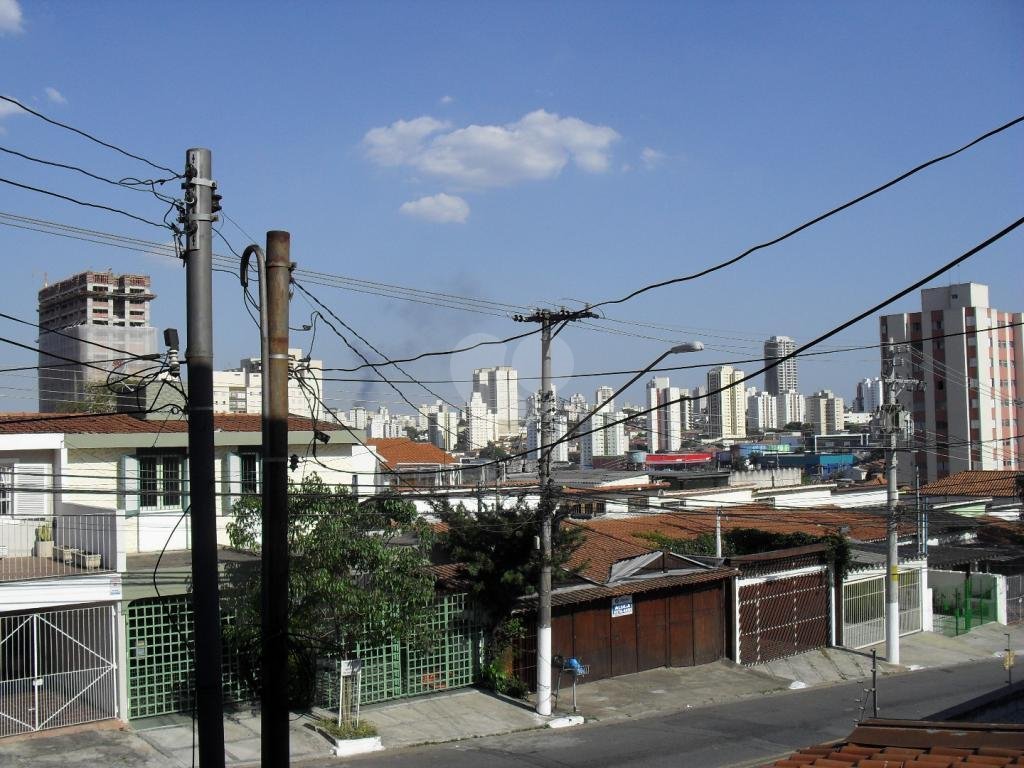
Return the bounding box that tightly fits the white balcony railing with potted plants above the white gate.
[0,514,118,582]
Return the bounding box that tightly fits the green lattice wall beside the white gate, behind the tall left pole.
[125,595,250,718]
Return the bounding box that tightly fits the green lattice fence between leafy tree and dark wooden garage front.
[315,594,483,709]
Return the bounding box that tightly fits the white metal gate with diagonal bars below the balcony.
[0,606,117,736]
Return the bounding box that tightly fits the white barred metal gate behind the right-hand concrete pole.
[843,569,922,648]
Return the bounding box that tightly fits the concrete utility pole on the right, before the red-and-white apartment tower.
[881,339,918,664]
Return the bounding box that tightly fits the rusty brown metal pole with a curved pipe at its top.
[260,231,292,768]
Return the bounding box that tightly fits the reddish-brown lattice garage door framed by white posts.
[739,569,829,664]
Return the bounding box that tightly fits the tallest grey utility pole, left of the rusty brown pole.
[181,148,224,768]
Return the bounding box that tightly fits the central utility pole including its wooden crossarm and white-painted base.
[513,307,597,717]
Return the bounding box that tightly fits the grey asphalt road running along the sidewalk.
[323,662,1006,768]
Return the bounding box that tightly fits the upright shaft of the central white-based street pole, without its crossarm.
[537,312,555,716]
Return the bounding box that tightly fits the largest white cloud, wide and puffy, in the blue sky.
[362,110,618,187]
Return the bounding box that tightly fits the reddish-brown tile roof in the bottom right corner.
[764,720,1024,768]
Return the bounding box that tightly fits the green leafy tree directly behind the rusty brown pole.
[223,474,434,707]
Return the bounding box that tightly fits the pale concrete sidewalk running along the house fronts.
[0,624,1024,768]
